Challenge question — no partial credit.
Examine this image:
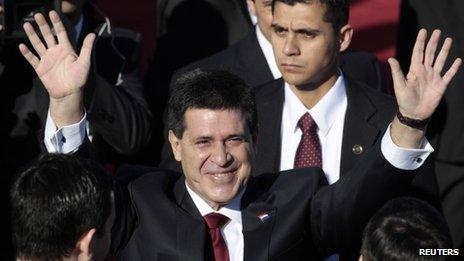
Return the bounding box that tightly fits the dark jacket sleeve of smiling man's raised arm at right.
[311,139,417,260]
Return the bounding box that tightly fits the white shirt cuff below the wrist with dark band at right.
[381,124,434,170]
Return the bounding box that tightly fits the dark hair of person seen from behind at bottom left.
[10,154,113,260]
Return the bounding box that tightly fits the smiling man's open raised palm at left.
[19,11,95,99]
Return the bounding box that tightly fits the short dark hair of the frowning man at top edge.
[272,0,350,31]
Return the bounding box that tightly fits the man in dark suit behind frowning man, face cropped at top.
[160,0,382,171]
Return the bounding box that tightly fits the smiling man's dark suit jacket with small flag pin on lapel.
[112,143,414,261]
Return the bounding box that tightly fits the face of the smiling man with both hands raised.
[169,108,253,209]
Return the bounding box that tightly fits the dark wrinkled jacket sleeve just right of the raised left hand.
[85,29,151,155]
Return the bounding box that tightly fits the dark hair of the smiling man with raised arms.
[168,69,257,138]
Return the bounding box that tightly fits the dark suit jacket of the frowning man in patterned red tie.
[253,77,440,206]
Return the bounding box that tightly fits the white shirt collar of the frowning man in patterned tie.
[284,72,346,136]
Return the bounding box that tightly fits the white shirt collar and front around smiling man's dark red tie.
[185,183,245,261]
